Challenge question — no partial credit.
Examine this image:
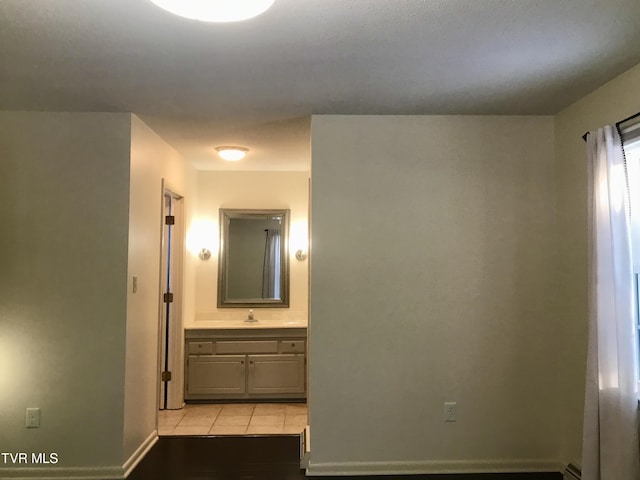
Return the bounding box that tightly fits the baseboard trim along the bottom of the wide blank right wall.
[306,456,564,476]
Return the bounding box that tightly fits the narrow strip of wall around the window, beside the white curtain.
[555,65,640,462]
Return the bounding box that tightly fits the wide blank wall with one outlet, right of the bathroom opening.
[309,116,561,473]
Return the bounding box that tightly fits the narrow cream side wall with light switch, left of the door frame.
[123,115,196,462]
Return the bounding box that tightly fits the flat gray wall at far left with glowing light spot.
[0,112,131,478]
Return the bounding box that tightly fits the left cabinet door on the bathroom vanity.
[187,355,246,395]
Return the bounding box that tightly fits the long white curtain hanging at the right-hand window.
[582,127,640,480]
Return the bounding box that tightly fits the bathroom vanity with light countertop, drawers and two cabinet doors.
[185,321,307,401]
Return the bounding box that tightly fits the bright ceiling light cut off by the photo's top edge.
[151,0,274,22]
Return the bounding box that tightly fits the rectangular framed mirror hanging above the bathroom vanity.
[218,208,289,308]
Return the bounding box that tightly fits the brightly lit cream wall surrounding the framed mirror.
[186,171,309,324]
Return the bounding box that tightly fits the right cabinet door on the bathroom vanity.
[247,355,305,394]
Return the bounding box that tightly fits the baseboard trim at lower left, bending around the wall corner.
[0,430,158,480]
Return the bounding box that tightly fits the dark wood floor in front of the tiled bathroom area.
[128,435,562,480]
